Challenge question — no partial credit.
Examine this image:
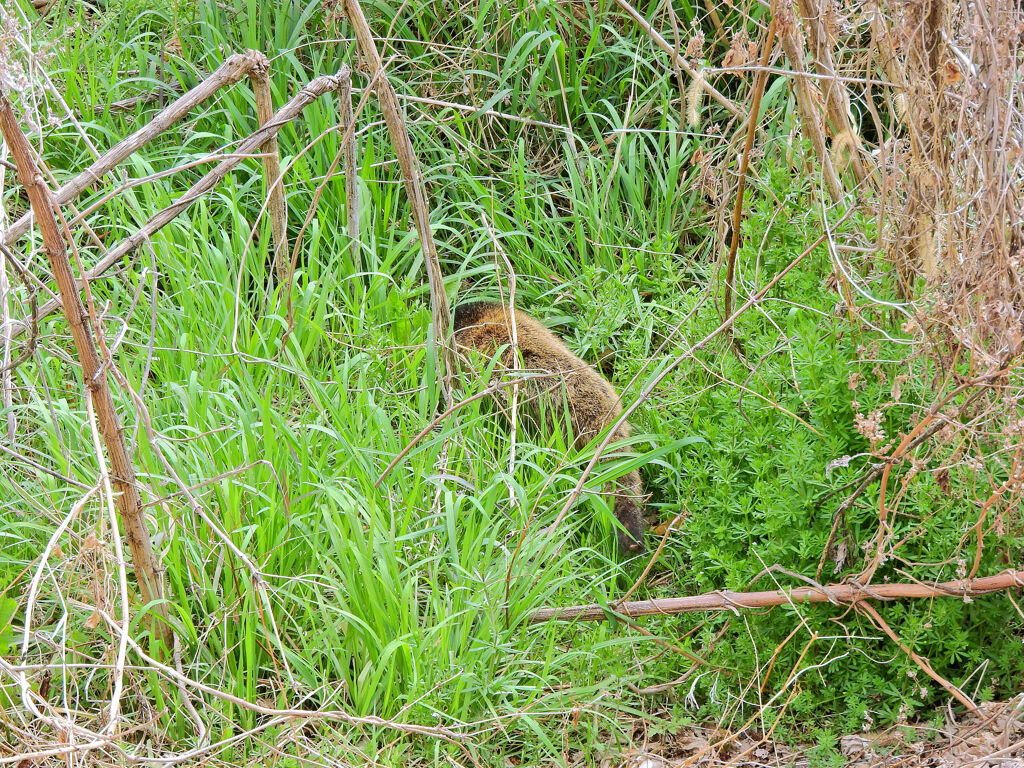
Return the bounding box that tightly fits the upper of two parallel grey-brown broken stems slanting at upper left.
[0,51,257,247]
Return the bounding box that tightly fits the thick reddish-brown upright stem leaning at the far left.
[0,95,171,648]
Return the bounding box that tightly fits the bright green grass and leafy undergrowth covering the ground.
[0,0,1024,765]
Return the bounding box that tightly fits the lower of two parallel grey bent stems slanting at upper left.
[14,75,348,336]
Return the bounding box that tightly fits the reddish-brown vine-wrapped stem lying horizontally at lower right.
[526,570,1024,624]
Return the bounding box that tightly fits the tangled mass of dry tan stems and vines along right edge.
[790,0,1024,575]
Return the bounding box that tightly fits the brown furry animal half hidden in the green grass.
[455,302,646,552]
